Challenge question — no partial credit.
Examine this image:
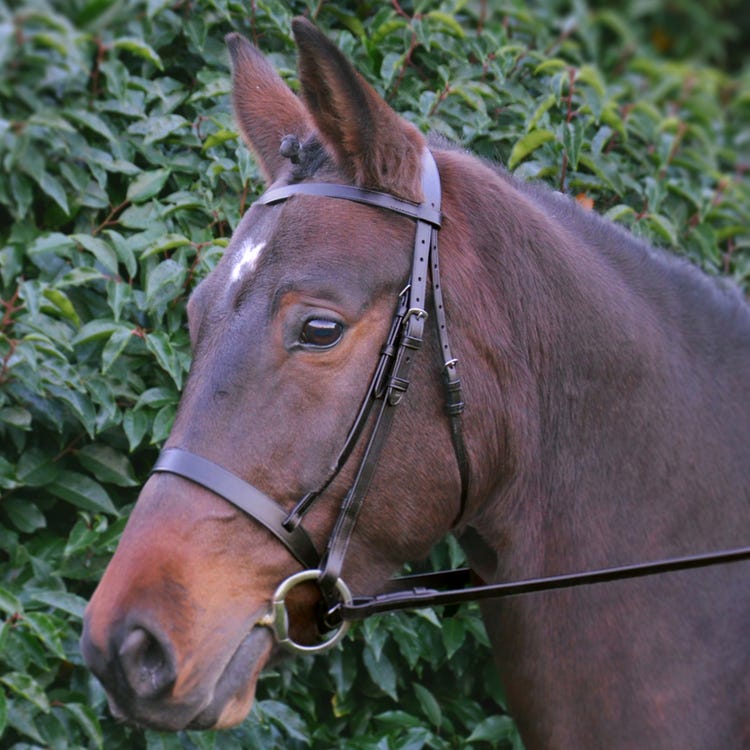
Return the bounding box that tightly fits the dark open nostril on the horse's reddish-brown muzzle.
[118,627,176,698]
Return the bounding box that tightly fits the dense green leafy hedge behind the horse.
[0,0,750,750]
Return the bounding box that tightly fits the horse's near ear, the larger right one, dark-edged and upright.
[292,18,424,202]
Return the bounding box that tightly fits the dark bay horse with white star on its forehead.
[82,19,750,750]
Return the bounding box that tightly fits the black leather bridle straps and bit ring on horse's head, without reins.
[153,149,469,650]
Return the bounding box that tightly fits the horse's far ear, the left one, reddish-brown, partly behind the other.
[226,34,313,182]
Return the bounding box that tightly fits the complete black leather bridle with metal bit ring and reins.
[153,149,750,652]
